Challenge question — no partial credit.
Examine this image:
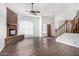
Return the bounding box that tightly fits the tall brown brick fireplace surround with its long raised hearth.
[5,8,24,46]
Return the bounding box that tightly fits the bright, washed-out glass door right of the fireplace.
[19,20,34,38]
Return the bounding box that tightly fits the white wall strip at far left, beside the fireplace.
[0,4,7,51]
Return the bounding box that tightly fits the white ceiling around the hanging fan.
[6,3,79,16]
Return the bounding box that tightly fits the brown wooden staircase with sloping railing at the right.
[56,18,79,36]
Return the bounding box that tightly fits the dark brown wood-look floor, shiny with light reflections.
[1,37,79,56]
